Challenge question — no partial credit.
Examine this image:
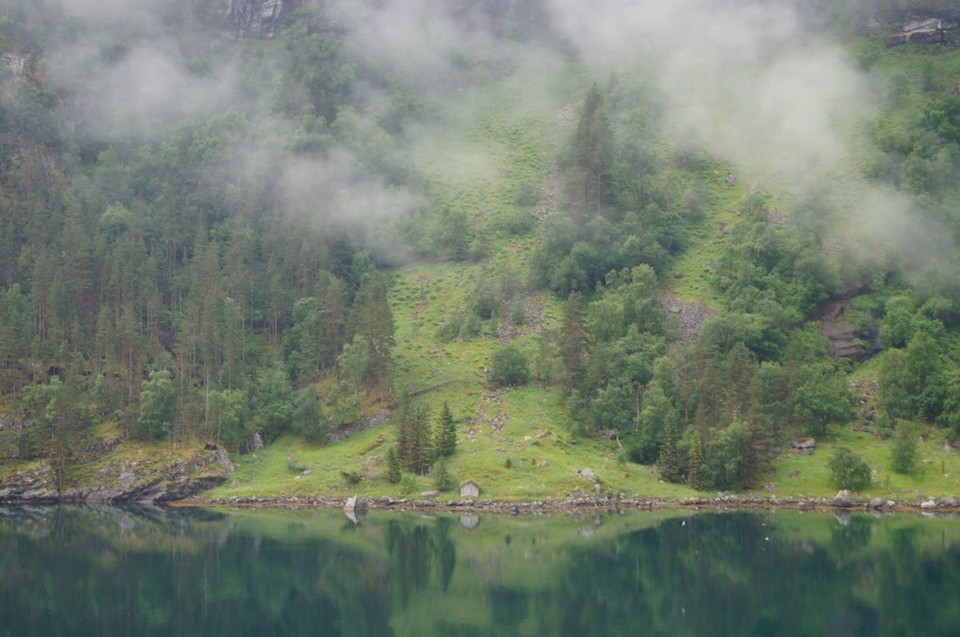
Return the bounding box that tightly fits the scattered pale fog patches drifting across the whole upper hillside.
[43,0,944,259]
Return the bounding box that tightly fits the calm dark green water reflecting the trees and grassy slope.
[0,506,960,637]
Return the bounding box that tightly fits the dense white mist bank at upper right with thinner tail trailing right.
[550,0,954,267]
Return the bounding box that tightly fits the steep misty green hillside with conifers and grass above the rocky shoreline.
[0,0,960,498]
